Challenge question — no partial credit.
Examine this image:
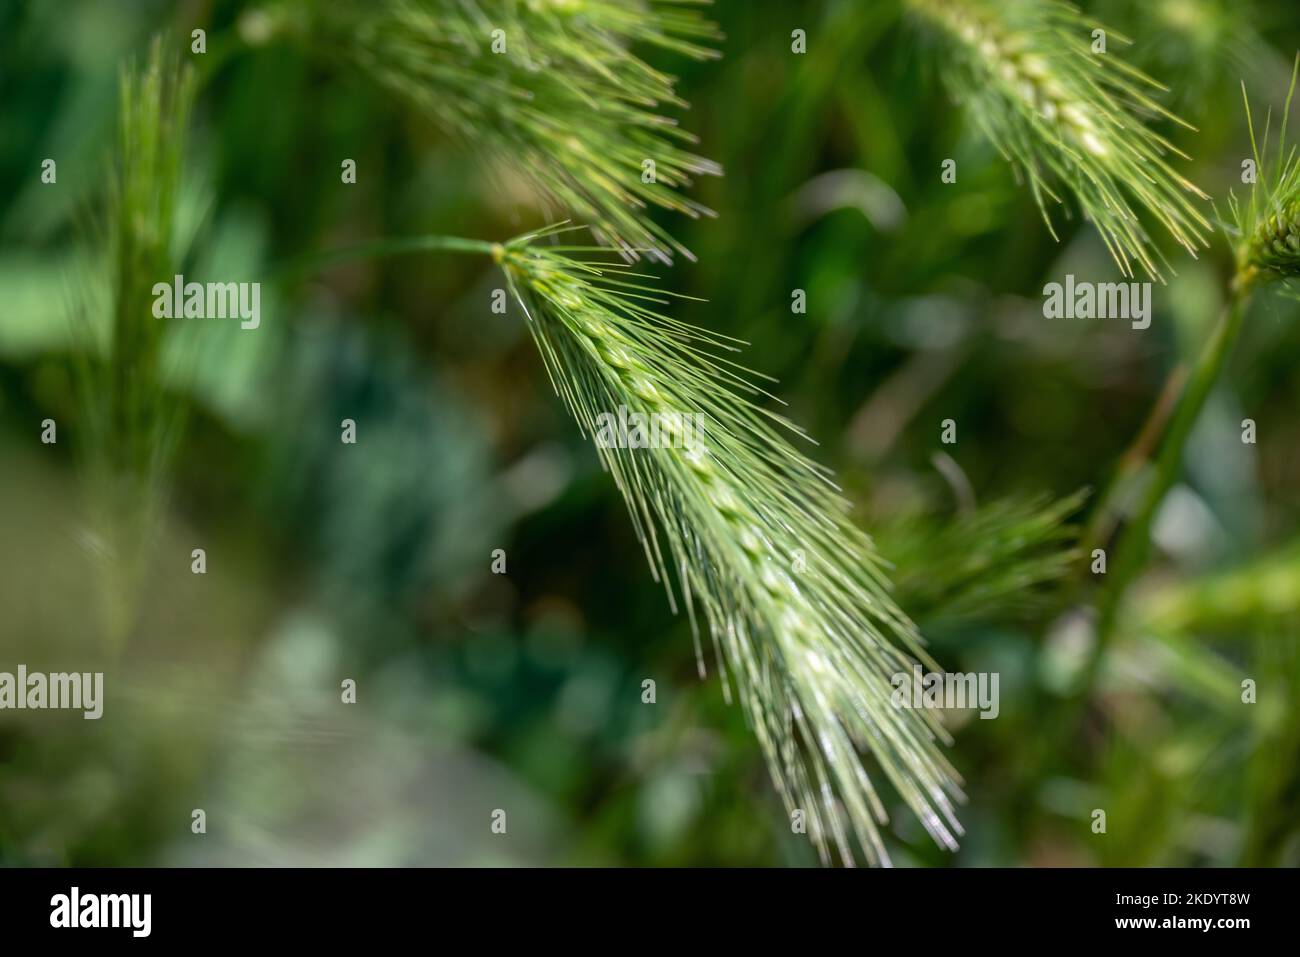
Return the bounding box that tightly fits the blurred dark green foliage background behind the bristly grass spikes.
[0,0,1300,866]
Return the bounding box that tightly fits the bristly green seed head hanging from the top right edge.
[907,0,1210,278]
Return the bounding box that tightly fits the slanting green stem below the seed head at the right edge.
[1079,283,1249,697]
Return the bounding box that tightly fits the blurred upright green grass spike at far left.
[75,38,195,645]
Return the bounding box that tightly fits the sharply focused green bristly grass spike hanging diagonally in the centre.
[493,230,961,865]
